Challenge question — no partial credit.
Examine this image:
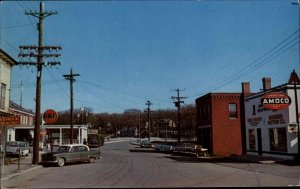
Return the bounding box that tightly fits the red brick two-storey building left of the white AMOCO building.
[196,93,242,156]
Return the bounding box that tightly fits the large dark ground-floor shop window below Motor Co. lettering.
[269,128,287,152]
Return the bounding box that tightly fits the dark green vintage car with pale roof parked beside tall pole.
[41,144,101,167]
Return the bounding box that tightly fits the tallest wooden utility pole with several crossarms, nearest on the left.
[17,1,61,164]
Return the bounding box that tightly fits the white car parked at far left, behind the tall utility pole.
[5,141,30,156]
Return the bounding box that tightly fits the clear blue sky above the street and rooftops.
[0,0,300,113]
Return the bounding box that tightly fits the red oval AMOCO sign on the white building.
[261,92,292,110]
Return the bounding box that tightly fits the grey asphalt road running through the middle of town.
[2,142,300,188]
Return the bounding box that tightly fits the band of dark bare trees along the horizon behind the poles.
[56,104,196,138]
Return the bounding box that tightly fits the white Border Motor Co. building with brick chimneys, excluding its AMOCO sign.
[243,72,300,159]
